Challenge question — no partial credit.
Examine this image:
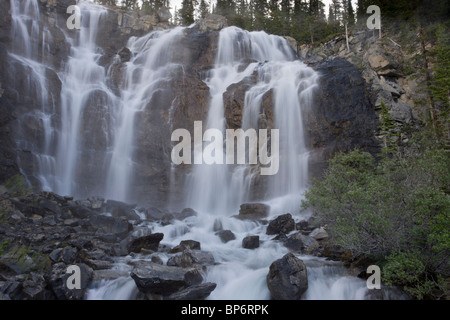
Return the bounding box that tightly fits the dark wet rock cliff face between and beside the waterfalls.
[0,0,398,206]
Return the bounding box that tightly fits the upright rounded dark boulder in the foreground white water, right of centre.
[266,253,308,300]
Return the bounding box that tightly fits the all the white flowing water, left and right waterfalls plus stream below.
[9,0,384,300]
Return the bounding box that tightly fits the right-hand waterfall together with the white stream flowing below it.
[88,27,367,300]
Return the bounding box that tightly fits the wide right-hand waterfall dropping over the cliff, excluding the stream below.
[187,27,318,216]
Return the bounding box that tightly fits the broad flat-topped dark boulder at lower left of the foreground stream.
[130,262,203,296]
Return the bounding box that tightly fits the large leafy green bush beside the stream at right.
[302,135,450,298]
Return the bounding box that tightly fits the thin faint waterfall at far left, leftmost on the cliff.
[8,0,56,191]
